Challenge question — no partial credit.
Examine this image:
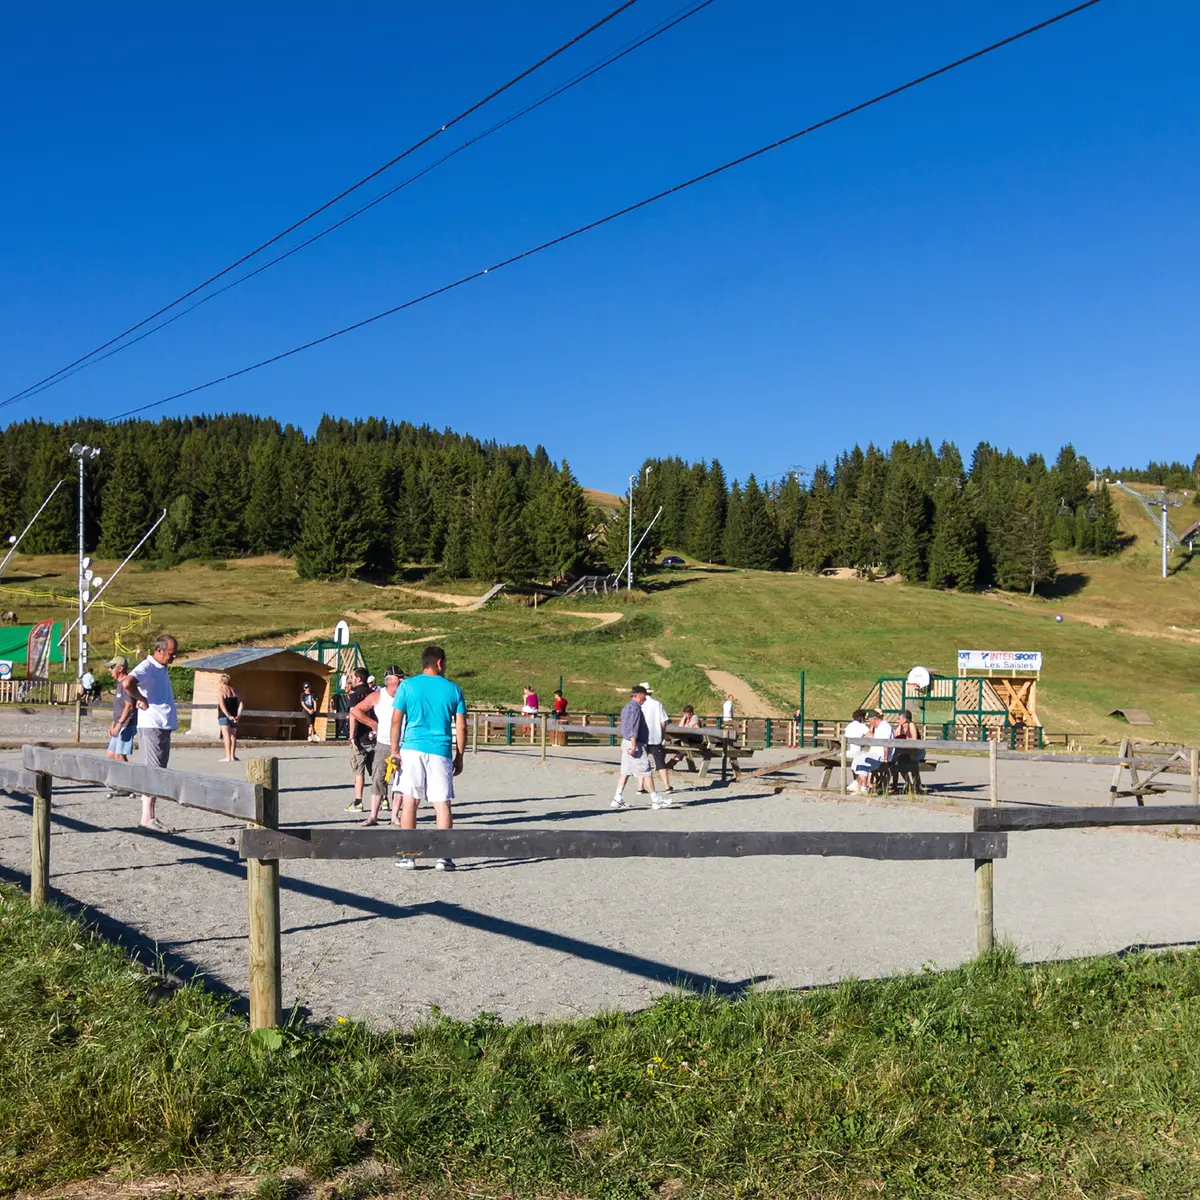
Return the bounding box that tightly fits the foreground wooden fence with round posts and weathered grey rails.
[7,731,1200,1028]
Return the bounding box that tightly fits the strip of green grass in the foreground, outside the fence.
[0,888,1200,1198]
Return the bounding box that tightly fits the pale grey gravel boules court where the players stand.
[0,742,1200,1025]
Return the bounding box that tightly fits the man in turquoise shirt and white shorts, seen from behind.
[391,646,467,871]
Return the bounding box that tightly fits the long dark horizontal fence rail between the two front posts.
[240,828,1008,862]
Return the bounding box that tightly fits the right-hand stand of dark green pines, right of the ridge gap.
[608,440,1120,592]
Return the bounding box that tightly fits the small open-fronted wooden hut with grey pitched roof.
[180,646,332,739]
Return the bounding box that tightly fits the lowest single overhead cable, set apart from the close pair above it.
[108,0,1100,421]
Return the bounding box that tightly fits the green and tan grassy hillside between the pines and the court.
[0,480,1200,742]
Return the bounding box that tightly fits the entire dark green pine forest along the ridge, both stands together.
[0,414,1171,592]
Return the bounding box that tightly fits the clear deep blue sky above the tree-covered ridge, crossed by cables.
[0,0,1200,490]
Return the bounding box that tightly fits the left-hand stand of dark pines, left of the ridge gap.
[0,415,601,581]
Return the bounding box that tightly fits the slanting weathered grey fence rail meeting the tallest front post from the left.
[20,745,263,821]
